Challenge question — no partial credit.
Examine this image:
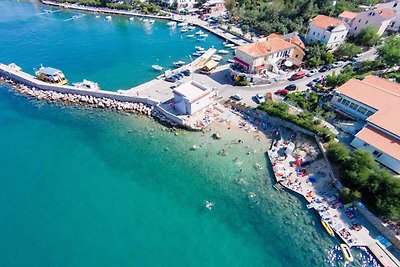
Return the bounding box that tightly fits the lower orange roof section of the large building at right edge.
[356,126,400,160]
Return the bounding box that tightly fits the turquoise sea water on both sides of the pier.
[0,0,382,267]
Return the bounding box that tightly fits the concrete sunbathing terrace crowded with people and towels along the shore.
[267,139,400,267]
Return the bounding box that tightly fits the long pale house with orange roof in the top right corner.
[339,8,396,36]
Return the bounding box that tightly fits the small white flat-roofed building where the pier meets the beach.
[173,82,215,115]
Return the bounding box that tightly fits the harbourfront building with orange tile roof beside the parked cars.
[234,38,296,74]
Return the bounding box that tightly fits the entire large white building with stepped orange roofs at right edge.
[332,75,400,173]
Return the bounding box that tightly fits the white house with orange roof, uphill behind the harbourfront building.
[306,15,349,50]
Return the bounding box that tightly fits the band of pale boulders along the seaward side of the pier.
[0,76,178,127]
